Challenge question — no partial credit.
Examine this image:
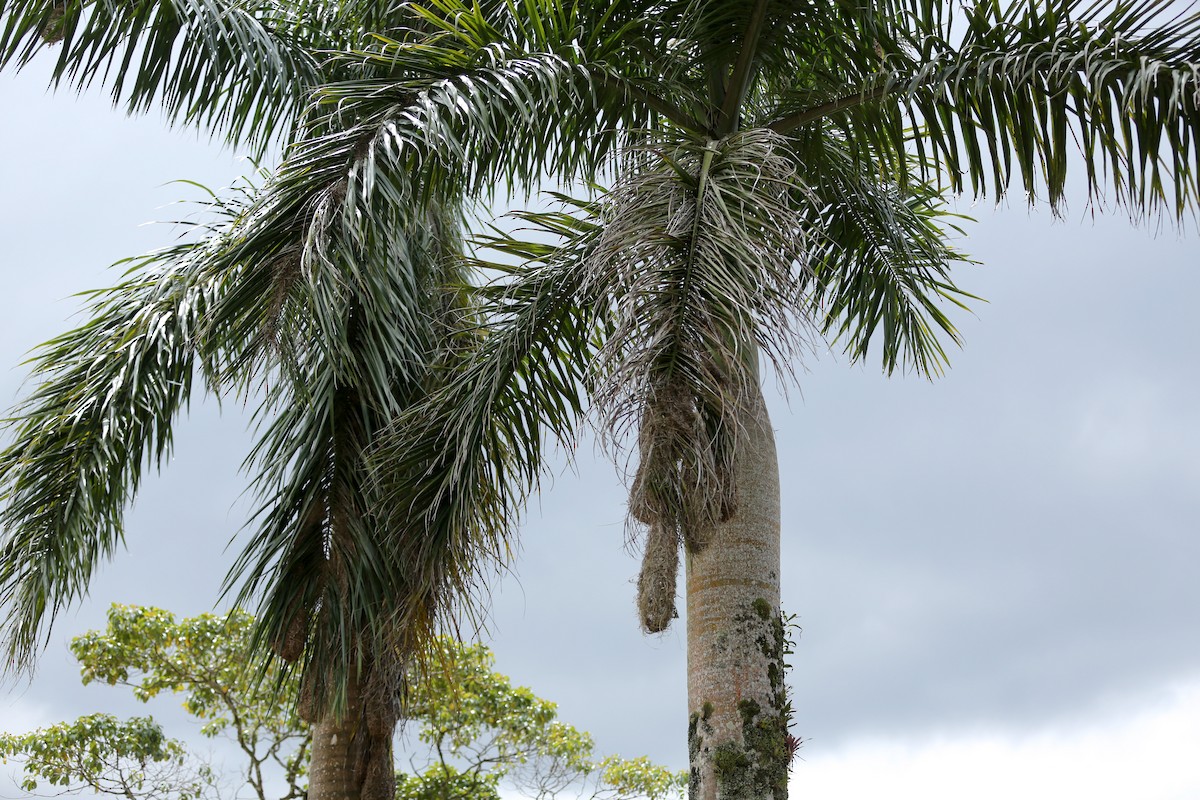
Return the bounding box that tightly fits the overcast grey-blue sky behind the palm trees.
[7,51,1200,800]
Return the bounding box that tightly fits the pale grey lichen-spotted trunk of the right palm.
[686,393,788,800]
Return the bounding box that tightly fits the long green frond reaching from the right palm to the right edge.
[770,0,1200,216]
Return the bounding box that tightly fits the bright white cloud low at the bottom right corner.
[791,676,1200,800]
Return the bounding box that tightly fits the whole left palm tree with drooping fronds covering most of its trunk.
[0,0,520,800]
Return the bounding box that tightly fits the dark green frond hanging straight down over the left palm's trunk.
[220,196,467,703]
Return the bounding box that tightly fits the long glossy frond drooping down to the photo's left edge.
[0,245,217,667]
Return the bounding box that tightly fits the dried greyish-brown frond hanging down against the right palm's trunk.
[583,131,816,614]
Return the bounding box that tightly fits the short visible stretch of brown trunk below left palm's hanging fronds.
[307,679,396,800]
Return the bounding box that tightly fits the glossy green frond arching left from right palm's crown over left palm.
[260,0,696,221]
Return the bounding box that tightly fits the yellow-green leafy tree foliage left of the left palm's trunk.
[0,604,312,800]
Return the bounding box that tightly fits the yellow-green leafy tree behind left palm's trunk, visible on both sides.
[0,606,684,800]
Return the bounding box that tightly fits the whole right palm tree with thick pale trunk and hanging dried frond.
[0,0,1200,799]
